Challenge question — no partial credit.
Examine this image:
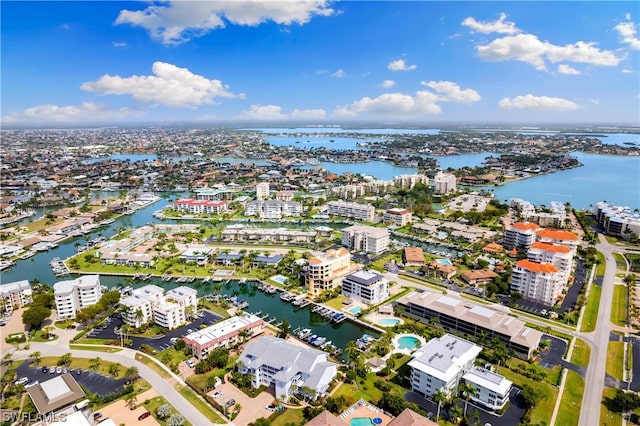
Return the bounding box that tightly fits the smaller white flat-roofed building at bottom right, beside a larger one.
[462,367,513,410]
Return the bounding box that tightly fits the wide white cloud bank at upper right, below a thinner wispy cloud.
[476,34,622,70]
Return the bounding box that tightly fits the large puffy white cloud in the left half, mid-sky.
[80,62,244,108]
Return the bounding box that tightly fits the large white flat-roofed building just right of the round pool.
[409,334,482,397]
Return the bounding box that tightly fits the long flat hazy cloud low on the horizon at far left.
[2,102,141,123]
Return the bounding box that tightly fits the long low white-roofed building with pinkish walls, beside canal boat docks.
[182,313,266,360]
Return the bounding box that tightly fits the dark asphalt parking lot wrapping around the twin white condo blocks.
[86,311,221,351]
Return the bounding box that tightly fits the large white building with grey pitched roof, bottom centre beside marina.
[238,336,338,400]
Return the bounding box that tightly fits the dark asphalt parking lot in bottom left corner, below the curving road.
[16,359,125,396]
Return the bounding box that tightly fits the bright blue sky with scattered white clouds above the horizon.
[0,0,640,126]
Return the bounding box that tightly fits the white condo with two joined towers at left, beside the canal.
[53,275,102,320]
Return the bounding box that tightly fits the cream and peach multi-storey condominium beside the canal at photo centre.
[305,247,355,294]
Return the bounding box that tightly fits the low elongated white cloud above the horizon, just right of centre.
[334,90,441,118]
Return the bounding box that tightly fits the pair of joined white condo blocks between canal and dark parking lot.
[120,284,198,329]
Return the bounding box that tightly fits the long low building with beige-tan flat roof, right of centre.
[395,290,542,359]
